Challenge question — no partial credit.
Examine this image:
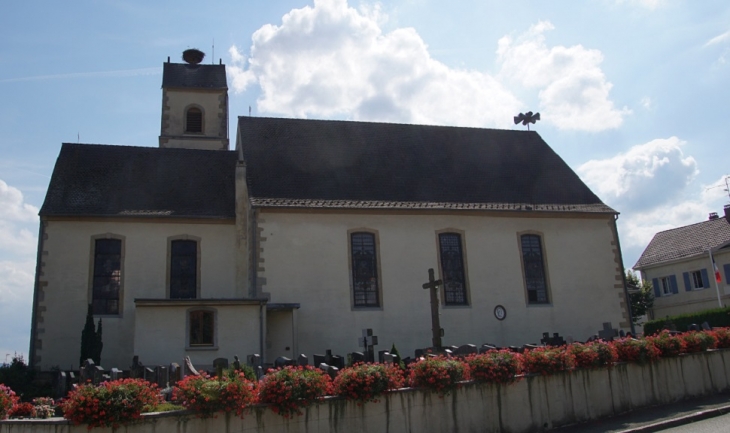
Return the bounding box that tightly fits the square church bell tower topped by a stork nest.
[160,48,229,150]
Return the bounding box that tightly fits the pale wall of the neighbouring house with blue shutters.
[641,246,730,319]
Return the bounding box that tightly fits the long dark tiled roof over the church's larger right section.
[239,117,614,212]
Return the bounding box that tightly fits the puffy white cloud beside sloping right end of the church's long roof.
[577,137,698,211]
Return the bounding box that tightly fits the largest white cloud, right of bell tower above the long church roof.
[229,0,521,127]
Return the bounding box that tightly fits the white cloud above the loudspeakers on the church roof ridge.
[497,21,631,131]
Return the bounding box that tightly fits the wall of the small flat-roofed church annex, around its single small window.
[134,301,266,368]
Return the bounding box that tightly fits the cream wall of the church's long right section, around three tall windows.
[258,210,625,362]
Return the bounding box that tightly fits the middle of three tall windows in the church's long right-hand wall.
[439,233,469,305]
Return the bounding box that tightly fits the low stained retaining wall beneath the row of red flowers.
[0,350,730,433]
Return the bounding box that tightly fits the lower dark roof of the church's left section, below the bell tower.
[40,143,237,218]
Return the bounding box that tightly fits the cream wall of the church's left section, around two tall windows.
[36,220,235,370]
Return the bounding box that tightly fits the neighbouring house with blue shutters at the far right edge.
[634,205,730,319]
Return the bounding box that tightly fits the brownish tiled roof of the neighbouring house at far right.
[634,217,730,268]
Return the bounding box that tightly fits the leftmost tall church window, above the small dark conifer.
[91,239,122,315]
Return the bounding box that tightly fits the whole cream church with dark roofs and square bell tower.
[30,52,630,370]
